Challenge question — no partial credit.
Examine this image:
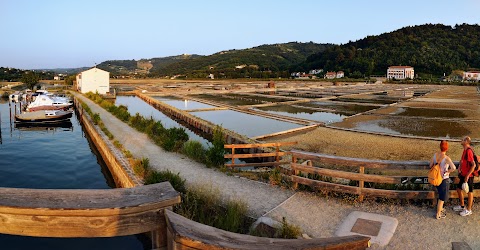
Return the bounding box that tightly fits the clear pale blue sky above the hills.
[0,0,480,69]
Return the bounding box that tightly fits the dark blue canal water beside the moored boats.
[0,98,144,250]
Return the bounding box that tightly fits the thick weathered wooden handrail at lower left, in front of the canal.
[0,182,180,237]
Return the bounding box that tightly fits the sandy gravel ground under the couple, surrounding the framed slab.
[267,192,480,249]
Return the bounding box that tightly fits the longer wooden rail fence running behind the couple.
[289,150,480,200]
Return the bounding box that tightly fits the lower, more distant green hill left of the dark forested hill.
[151,42,333,78]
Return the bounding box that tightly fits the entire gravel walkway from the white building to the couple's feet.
[76,94,480,249]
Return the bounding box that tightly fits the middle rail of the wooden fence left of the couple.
[290,163,402,184]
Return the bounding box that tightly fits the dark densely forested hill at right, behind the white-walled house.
[298,24,480,76]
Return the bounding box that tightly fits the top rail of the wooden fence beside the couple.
[290,150,429,169]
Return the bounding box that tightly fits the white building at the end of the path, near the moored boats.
[77,67,110,95]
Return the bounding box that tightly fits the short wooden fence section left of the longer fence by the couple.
[224,142,297,168]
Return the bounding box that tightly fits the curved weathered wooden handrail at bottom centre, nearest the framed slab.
[165,210,370,250]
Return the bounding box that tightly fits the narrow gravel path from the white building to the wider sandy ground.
[75,94,294,217]
